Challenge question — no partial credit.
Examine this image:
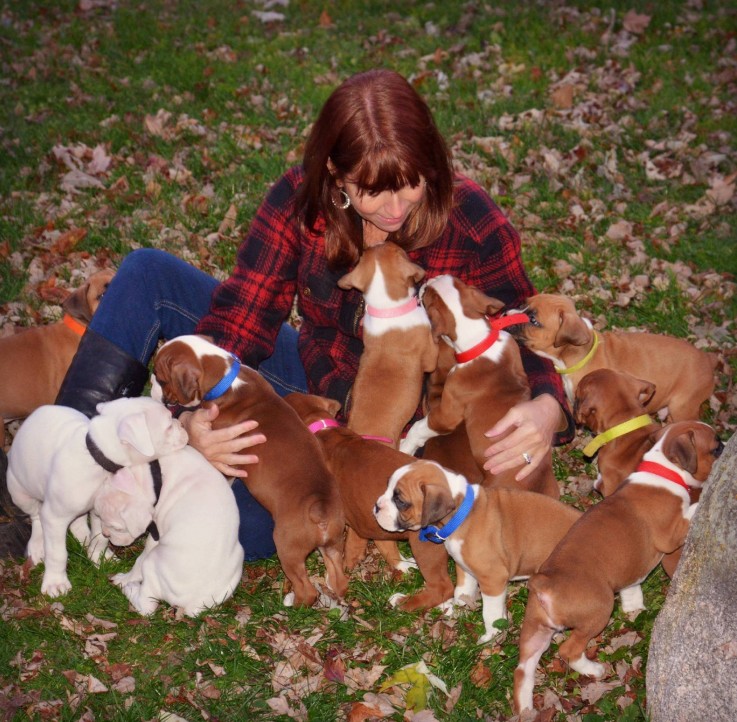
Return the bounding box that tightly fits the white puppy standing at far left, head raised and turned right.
[8,397,187,597]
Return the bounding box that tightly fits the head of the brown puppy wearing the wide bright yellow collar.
[573,369,655,434]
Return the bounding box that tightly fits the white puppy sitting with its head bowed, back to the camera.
[94,446,243,617]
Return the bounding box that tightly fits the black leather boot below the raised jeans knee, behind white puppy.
[56,329,148,418]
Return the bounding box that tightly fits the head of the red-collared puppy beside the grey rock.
[645,421,724,489]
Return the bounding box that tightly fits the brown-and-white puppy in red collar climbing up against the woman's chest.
[400,275,560,499]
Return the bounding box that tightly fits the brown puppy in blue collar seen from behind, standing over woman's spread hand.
[151,335,348,606]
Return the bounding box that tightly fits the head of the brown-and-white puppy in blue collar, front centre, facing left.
[374,461,465,531]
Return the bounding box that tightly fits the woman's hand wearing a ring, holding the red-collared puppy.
[484,394,565,481]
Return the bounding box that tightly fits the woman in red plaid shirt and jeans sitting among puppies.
[57,70,572,559]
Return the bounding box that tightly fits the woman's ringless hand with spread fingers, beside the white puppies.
[179,404,266,478]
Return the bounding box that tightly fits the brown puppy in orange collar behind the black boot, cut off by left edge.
[0,269,114,428]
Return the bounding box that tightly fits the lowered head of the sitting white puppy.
[94,464,154,546]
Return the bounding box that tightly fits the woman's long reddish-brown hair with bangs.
[297,70,453,268]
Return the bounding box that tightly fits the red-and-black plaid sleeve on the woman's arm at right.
[410,176,575,444]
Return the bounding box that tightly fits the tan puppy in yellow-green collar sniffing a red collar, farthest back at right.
[510,293,717,421]
